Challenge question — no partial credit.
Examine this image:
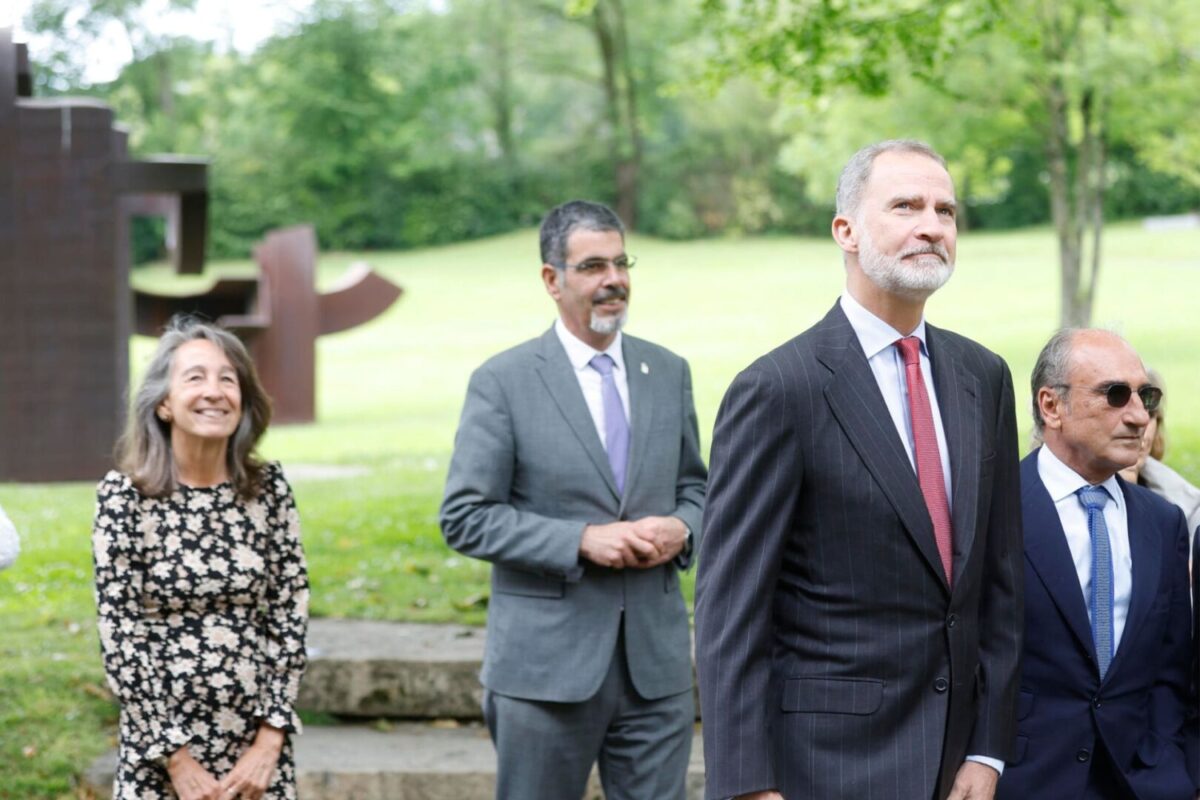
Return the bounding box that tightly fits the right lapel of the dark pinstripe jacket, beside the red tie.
[925,323,983,585]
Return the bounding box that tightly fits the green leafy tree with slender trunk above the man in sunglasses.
[706,0,1200,325]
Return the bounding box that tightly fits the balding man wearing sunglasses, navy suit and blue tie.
[996,330,1198,800]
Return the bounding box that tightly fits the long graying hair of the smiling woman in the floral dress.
[116,314,271,500]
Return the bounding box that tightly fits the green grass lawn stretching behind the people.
[0,225,1200,799]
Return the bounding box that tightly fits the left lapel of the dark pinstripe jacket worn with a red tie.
[816,303,949,594]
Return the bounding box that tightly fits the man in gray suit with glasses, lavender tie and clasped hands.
[442,200,706,800]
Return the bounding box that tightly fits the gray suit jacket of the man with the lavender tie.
[442,329,706,703]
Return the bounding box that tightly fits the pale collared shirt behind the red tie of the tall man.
[839,291,954,510]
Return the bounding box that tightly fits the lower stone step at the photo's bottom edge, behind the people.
[84,722,704,800]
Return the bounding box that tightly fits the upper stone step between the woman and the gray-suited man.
[296,619,484,720]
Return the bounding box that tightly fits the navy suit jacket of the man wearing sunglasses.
[996,451,1195,800]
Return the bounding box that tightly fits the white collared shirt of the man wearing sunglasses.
[1038,446,1133,652]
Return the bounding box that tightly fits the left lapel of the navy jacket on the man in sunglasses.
[1021,450,1111,673]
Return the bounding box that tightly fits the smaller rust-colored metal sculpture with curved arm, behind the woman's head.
[134,225,402,422]
